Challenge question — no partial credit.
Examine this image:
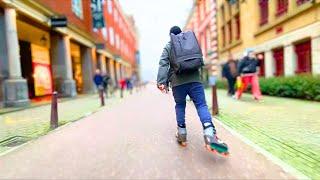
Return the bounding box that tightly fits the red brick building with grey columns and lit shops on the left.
[0,0,138,106]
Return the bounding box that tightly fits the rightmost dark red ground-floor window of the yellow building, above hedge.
[295,40,311,74]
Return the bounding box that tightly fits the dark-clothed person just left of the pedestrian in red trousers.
[222,53,238,96]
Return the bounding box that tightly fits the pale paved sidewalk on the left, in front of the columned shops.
[0,92,126,153]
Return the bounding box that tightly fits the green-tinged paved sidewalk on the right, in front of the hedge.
[206,89,320,179]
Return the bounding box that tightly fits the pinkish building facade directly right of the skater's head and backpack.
[184,0,218,81]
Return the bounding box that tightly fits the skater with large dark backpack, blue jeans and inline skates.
[157,26,228,155]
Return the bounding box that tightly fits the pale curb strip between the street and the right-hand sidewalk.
[213,117,310,179]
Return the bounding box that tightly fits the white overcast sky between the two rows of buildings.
[119,0,193,80]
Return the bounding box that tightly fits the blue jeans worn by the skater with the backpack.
[172,82,212,126]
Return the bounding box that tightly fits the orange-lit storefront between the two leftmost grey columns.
[17,20,53,99]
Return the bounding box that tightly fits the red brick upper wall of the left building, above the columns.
[36,0,137,64]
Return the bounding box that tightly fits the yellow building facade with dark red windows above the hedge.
[217,0,320,77]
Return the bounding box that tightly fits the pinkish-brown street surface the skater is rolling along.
[0,85,295,179]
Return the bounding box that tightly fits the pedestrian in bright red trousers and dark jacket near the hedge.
[235,49,262,100]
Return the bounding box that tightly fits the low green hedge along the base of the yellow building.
[217,75,320,101]
